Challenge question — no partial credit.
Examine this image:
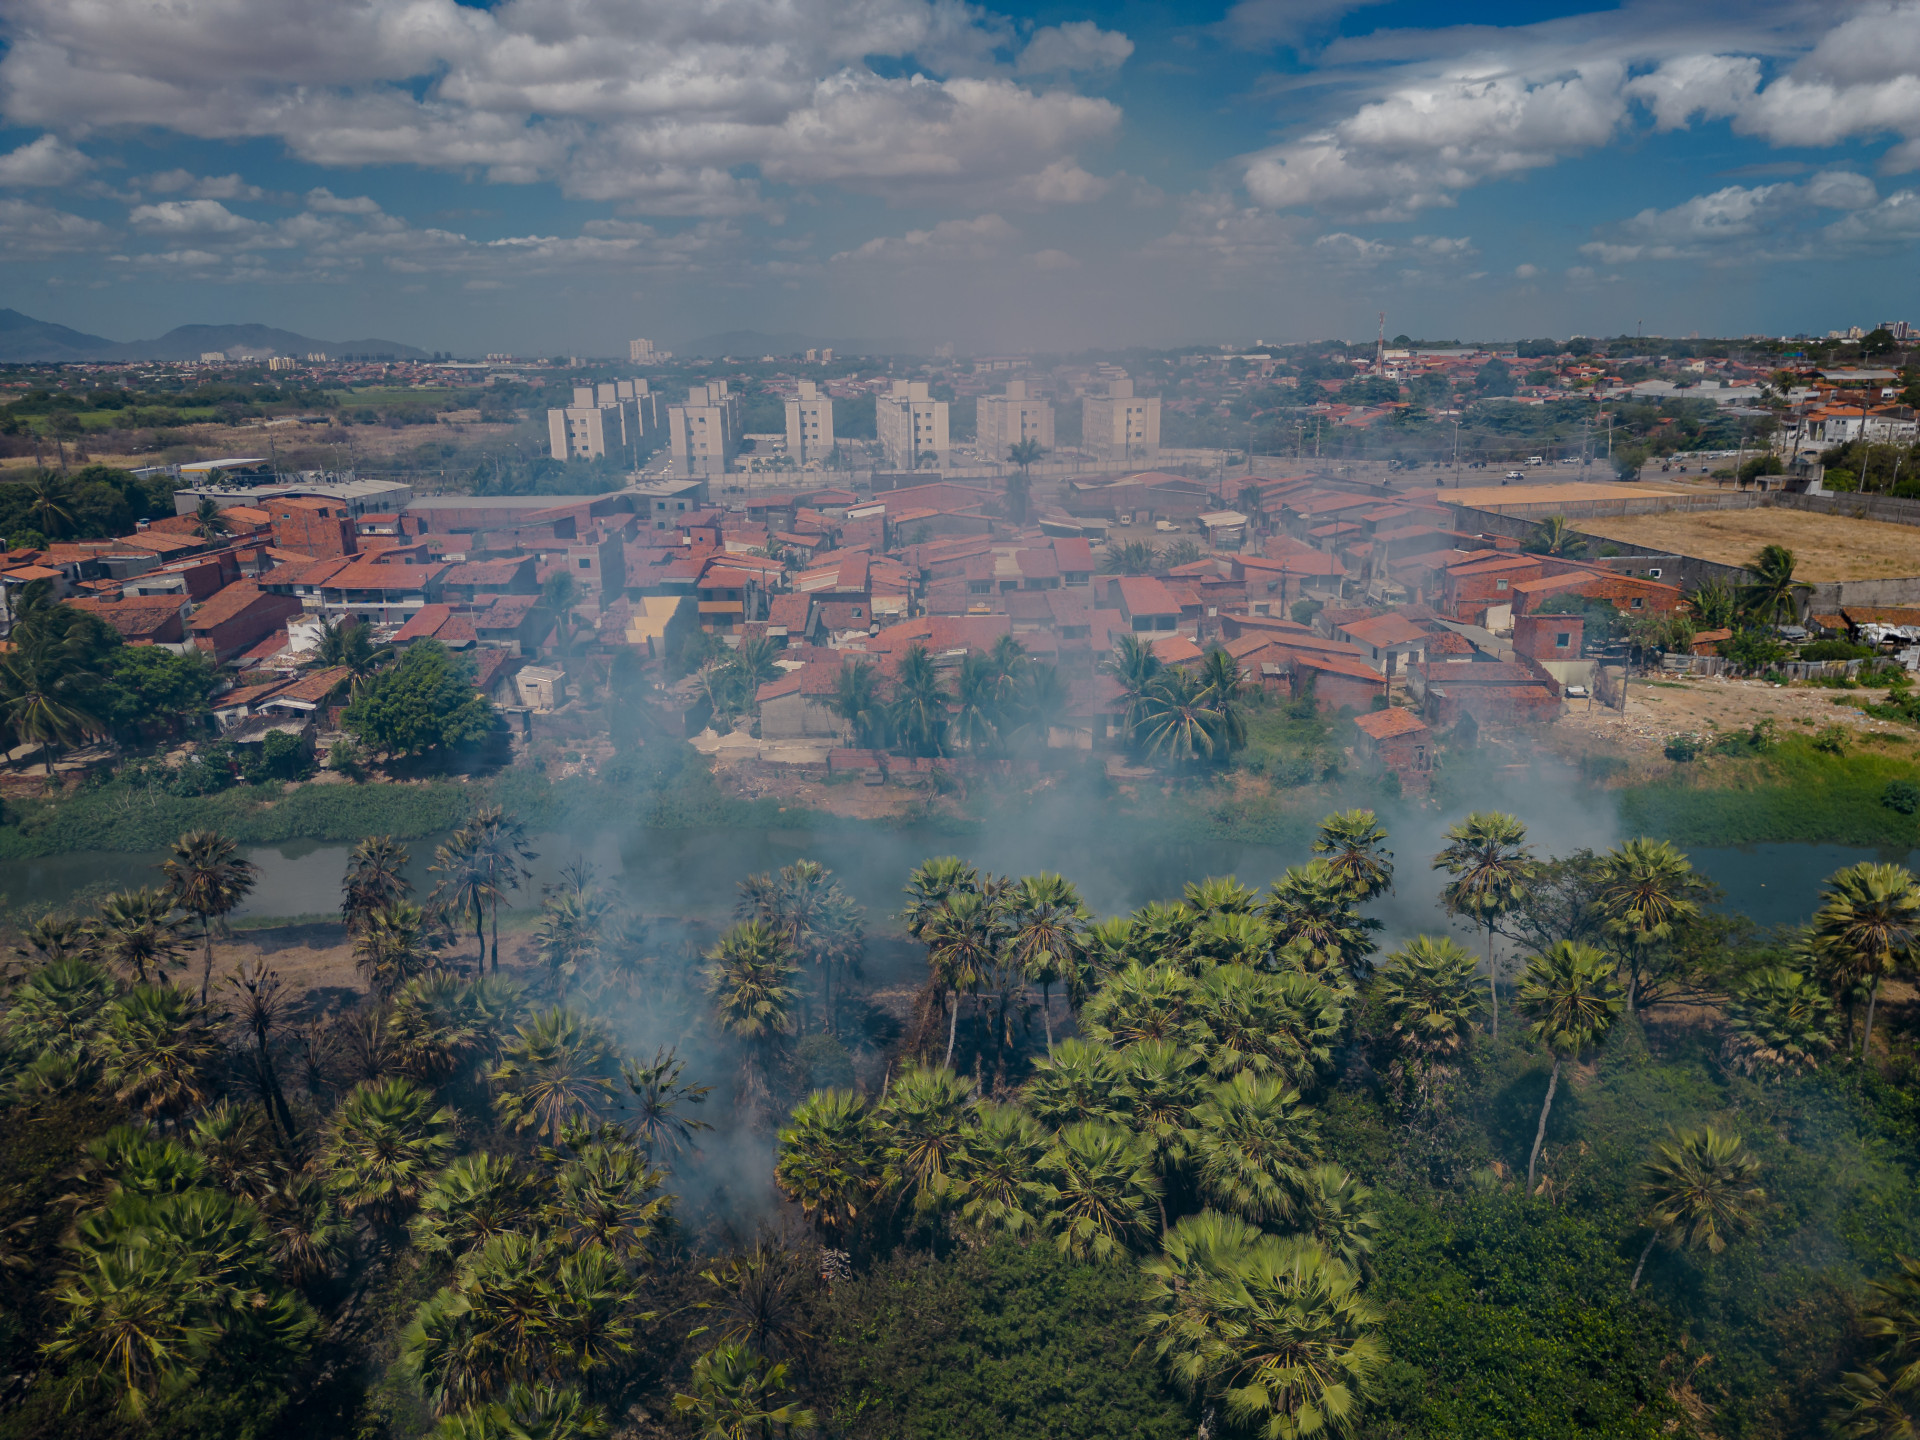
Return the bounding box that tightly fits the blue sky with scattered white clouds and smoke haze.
[0,0,1920,353]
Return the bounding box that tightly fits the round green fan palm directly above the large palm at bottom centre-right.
[1192,1071,1319,1225]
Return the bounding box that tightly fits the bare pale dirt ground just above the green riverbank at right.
[1557,678,1912,768]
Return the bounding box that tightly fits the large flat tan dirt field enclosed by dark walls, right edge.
[1572,511,1920,580]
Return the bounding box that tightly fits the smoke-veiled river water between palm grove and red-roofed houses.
[0,816,1920,943]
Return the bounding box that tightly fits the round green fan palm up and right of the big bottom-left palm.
[326,1079,453,1225]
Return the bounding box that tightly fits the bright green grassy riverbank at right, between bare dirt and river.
[1620,735,1920,849]
